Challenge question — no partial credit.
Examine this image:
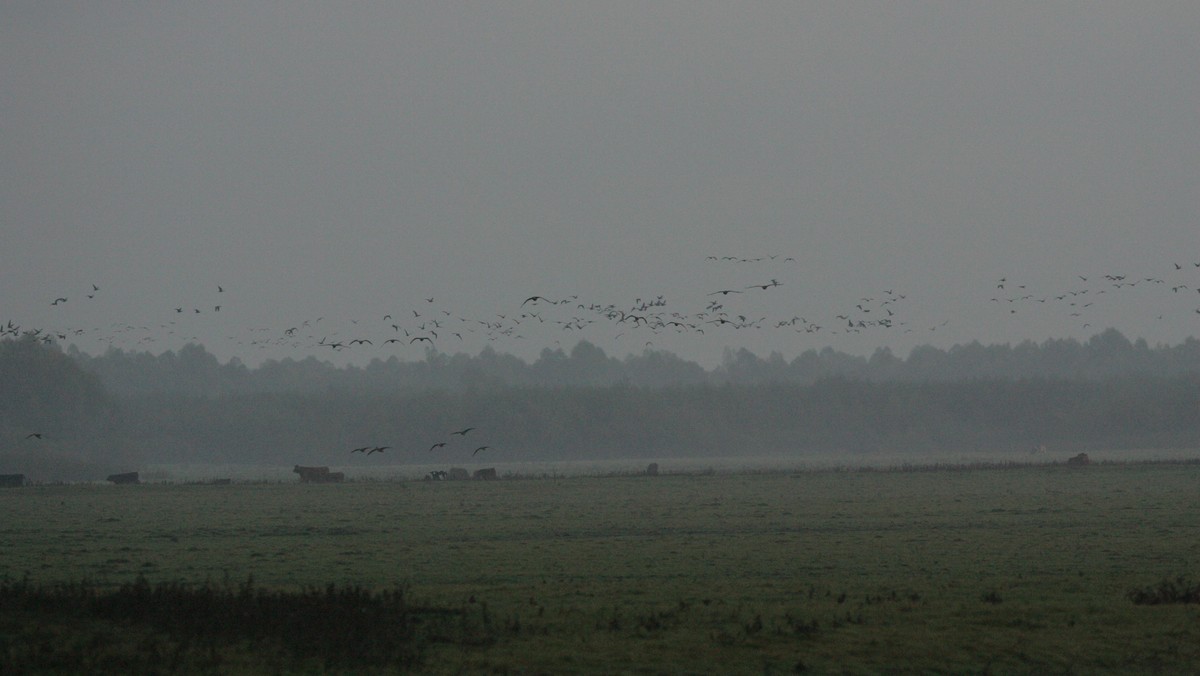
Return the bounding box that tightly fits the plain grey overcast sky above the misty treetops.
[0,0,1200,365]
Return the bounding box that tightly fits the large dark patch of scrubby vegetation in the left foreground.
[0,578,479,670]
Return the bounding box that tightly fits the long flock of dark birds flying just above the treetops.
[9,255,1200,367]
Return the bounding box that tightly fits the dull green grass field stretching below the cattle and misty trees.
[0,463,1200,674]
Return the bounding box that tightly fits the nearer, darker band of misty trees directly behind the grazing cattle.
[110,376,1200,465]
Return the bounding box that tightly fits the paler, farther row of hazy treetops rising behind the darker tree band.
[68,329,1200,396]
